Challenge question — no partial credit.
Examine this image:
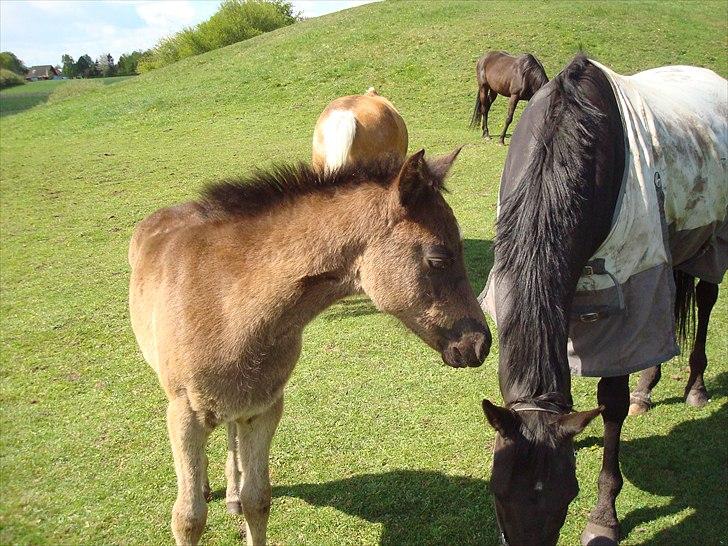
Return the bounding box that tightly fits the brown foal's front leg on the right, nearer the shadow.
[238,398,283,546]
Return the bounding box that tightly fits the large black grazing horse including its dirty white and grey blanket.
[481,55,728,546]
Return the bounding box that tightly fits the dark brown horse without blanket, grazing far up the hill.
[470,51,549,144]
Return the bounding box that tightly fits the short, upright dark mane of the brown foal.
[198,154,402,217]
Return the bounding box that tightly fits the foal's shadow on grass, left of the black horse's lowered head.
[273,470,497,546]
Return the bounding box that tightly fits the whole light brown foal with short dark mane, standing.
[129,150,491,546]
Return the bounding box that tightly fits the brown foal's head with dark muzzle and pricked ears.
[359,149,491,367]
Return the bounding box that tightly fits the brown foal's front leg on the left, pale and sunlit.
[167,397,215,546]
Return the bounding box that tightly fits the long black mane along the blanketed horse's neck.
[495,55,605,398]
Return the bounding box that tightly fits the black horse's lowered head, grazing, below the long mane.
[483,400,602,546]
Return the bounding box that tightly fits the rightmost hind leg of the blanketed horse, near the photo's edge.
[685,281,718,408]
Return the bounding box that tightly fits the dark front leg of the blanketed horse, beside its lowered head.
[581,375,629,546]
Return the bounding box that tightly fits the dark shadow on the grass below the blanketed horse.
[576,372,728,546]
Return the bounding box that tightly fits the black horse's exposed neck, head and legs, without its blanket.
[483,55,724,546]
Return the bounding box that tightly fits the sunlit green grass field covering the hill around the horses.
[0,1,728,546]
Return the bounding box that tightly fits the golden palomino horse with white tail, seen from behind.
[312,87,407,171]
